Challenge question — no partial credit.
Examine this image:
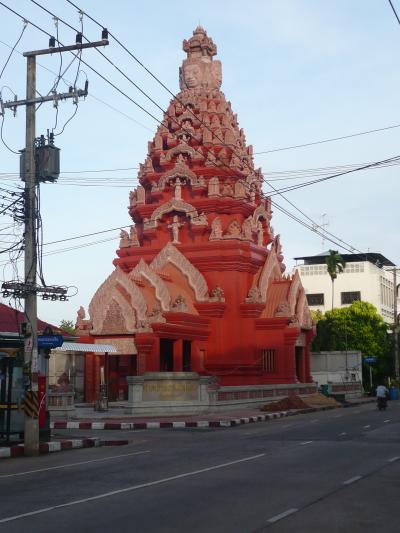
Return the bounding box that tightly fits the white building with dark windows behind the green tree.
[295,252,400,324]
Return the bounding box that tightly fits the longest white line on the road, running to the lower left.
[0,453,266,524]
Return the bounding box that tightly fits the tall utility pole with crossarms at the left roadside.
[0,29,109,455]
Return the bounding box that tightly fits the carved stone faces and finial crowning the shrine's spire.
[179,26,222,90]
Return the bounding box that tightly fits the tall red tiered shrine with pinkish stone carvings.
[77,27,314,397]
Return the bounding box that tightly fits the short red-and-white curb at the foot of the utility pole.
[0,437,129,459]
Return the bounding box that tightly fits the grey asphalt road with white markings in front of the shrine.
[0,402,400,533]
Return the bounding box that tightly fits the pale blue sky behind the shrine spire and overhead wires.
[0,0,400,325]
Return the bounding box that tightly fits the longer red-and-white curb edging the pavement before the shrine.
[50,405,337,430]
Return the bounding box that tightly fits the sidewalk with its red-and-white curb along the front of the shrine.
[50,398,375,430]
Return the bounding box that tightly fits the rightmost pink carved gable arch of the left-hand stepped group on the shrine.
[150,242,208,302]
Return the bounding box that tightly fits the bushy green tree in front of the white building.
[312,301,393,381]
